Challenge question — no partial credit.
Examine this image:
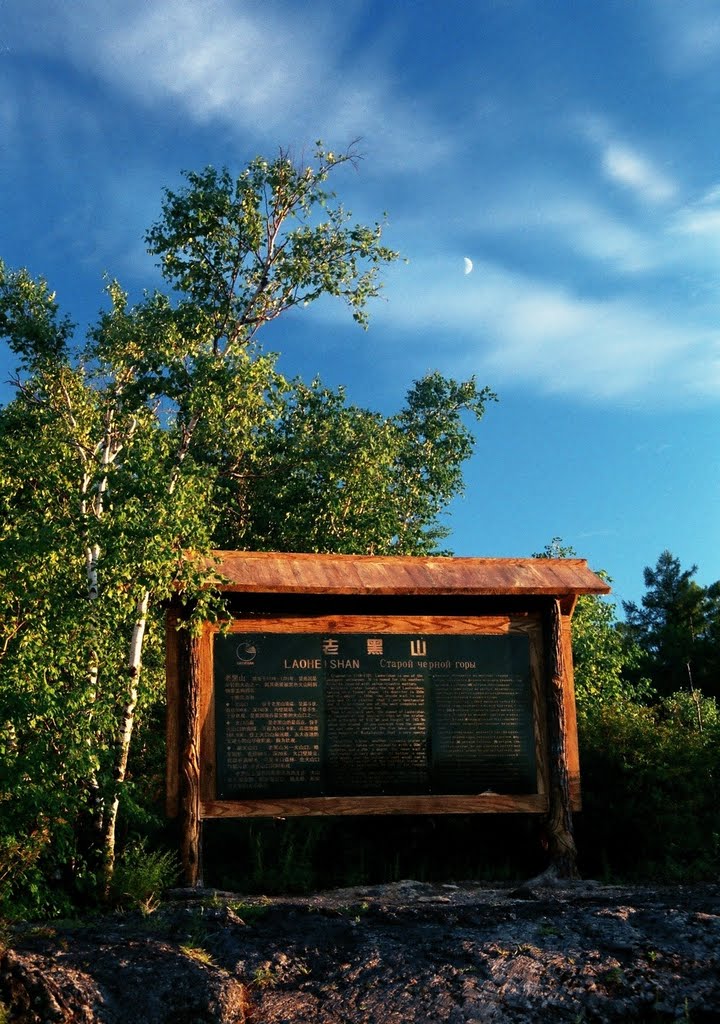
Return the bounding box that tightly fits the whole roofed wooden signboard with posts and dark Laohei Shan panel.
[168,552,608,884]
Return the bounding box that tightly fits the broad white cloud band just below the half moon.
[352,260,720,402]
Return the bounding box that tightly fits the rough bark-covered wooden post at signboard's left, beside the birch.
[179,630,201,886]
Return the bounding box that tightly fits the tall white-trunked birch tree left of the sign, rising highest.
[0,146,395,897]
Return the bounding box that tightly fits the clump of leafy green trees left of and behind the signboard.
[0,146,495,913]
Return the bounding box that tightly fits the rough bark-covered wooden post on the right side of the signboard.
[547,599,579,879]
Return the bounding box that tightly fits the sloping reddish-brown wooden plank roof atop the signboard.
[206,551,610,598]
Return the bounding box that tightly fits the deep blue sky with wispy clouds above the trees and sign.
[0,0,720,600]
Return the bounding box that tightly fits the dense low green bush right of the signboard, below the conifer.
[577,692,720,882]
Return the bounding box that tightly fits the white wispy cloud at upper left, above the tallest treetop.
[7,0,454,167]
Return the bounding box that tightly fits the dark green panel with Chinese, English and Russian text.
[214,633,537,800]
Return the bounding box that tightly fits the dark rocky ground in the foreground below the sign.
[0,882,720,1024]
